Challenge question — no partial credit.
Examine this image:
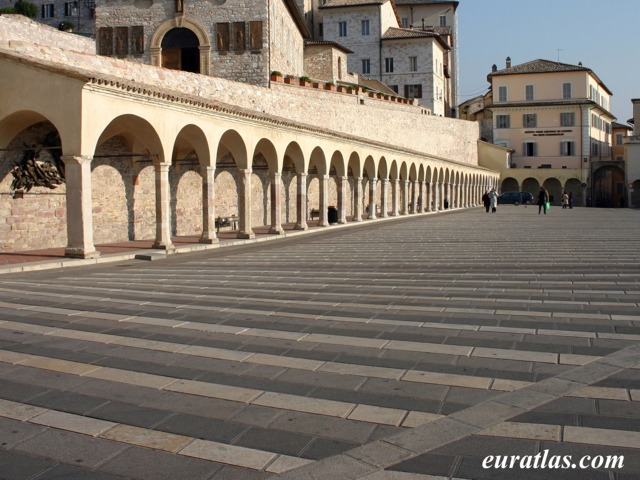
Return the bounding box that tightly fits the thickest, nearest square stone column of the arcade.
[60,156,100,258]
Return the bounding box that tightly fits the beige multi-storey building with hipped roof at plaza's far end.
[487,58,625,206]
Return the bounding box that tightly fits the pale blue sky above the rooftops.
[458,0,640,124]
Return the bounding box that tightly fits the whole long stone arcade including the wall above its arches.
[0,16,498,258]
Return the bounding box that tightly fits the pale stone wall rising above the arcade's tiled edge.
[0,14,479,166]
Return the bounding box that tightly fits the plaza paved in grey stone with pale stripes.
[0,206,640,480]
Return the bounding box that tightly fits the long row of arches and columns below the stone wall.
[0,111,497,258]
